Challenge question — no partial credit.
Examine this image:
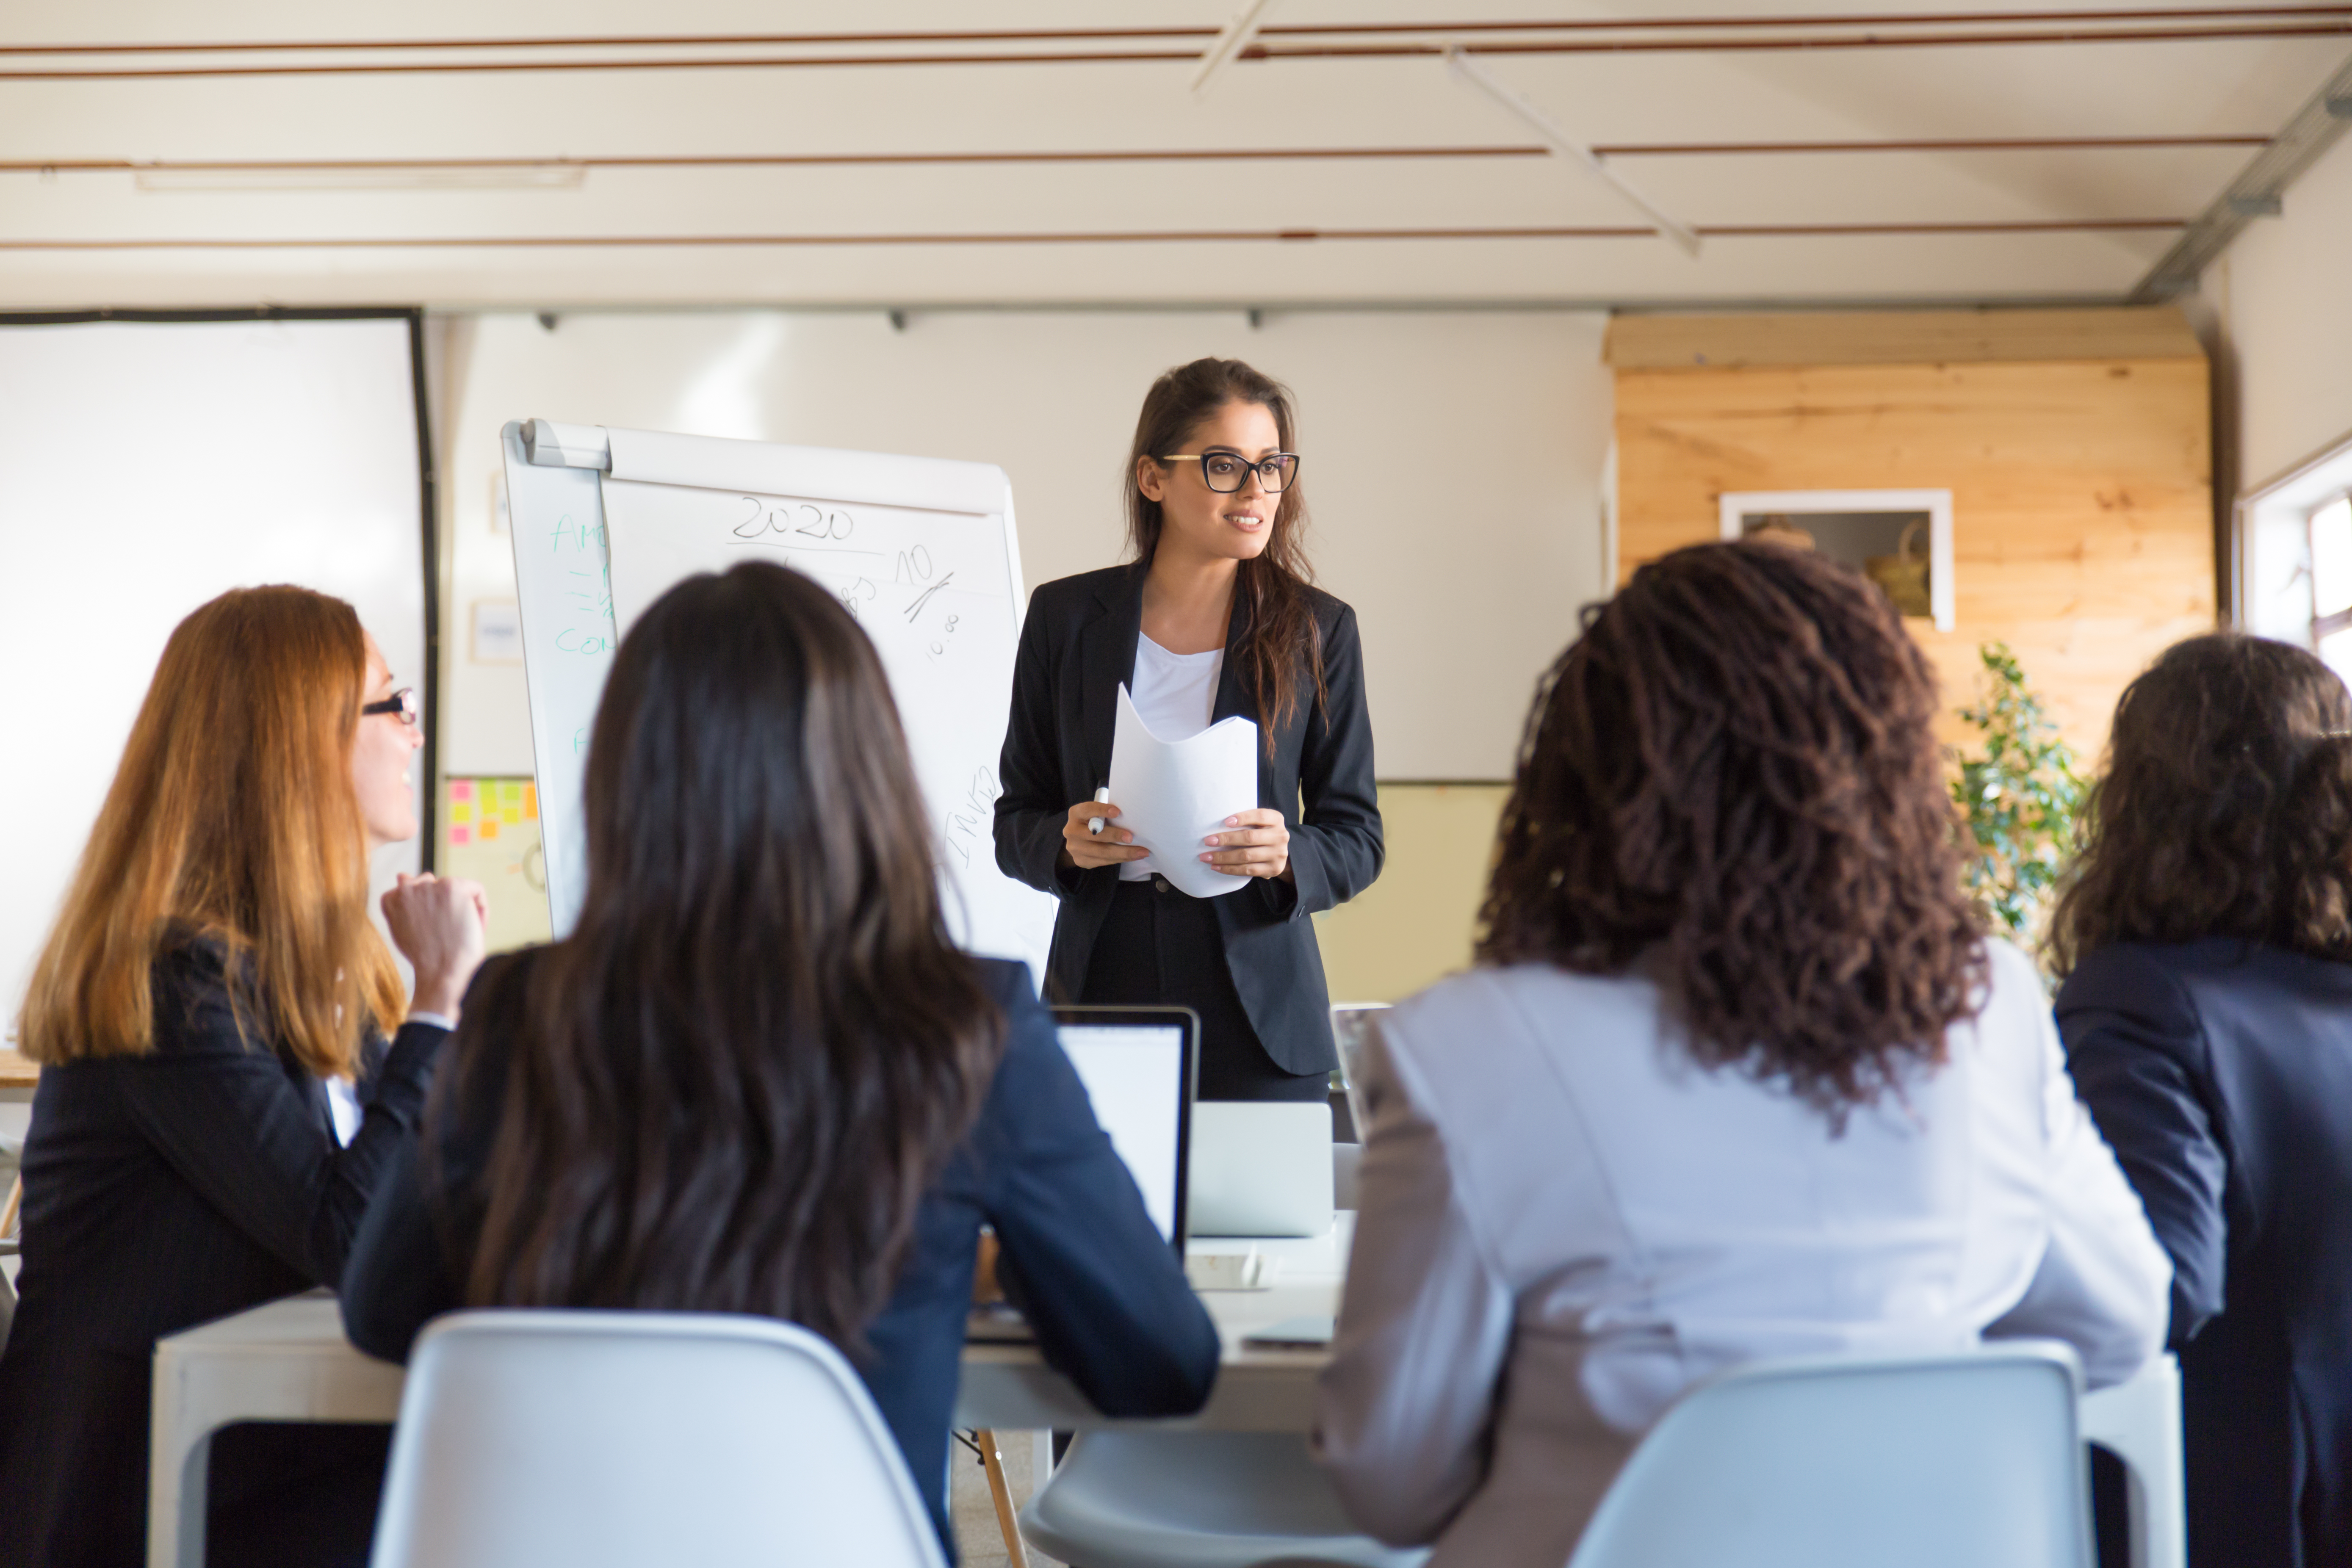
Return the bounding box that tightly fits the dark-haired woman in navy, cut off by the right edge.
[2051,635,2352,1568]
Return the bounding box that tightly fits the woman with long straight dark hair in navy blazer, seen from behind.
[343,562,1218,1556]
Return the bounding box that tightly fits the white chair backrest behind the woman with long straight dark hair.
[372,1312,943,1568]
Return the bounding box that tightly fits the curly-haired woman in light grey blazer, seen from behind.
[1320,543,2166,1568]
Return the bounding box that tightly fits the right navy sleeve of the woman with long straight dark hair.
[976,980,1218,1415]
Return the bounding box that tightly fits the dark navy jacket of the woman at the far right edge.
[2058,938,2352,1568]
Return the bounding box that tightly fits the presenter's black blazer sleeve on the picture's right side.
[1258,606,1385,919]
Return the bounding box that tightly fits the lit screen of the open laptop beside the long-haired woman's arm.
[1054,1006,1200,1253]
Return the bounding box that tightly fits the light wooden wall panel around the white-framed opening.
[1616,357,2213,757]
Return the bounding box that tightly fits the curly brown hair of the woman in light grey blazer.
[1477,543,1987,1119]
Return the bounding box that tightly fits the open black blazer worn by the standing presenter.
[997,564,1383,1072]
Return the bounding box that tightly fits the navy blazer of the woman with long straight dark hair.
[343,952,1218,1561]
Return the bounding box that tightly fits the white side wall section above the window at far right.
[2204,136,2352,491]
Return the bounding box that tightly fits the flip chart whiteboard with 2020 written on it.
[506,421,1054,976]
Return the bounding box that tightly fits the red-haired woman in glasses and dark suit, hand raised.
[0,588,482,1568]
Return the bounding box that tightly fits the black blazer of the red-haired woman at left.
[0,943,447,1568]
